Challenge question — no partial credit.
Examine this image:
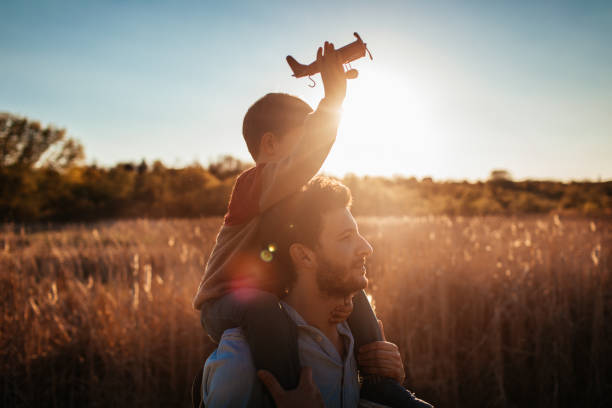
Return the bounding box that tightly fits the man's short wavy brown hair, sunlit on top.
[260,176,352,288]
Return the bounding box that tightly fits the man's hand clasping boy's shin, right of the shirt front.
[357,320,406,384]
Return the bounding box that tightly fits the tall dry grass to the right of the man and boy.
[366,216,612,407]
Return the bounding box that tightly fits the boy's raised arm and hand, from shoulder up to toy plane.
[259,41,346,212]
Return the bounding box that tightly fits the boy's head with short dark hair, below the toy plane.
[242,93,312,163]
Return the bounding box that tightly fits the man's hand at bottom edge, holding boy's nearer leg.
[257,367,325,408]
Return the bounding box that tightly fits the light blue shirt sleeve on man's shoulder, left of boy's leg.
[202,328,263,408]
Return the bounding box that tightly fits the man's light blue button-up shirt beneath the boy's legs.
[202,302,359,408]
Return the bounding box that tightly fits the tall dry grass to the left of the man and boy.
[0,219,219,407]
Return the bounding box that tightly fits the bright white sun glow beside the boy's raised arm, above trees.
[324,64,435,175]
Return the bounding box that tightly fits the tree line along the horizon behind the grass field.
[0,113,612,222]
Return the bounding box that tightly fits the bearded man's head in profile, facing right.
[262,177,372,297]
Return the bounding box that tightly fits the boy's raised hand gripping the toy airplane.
[317,41,346,107]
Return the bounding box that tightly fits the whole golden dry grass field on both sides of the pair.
[0,216,612,407]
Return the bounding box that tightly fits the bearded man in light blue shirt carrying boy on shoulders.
[202,177,429,408]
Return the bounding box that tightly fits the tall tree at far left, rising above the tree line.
[0,112,84,170]
